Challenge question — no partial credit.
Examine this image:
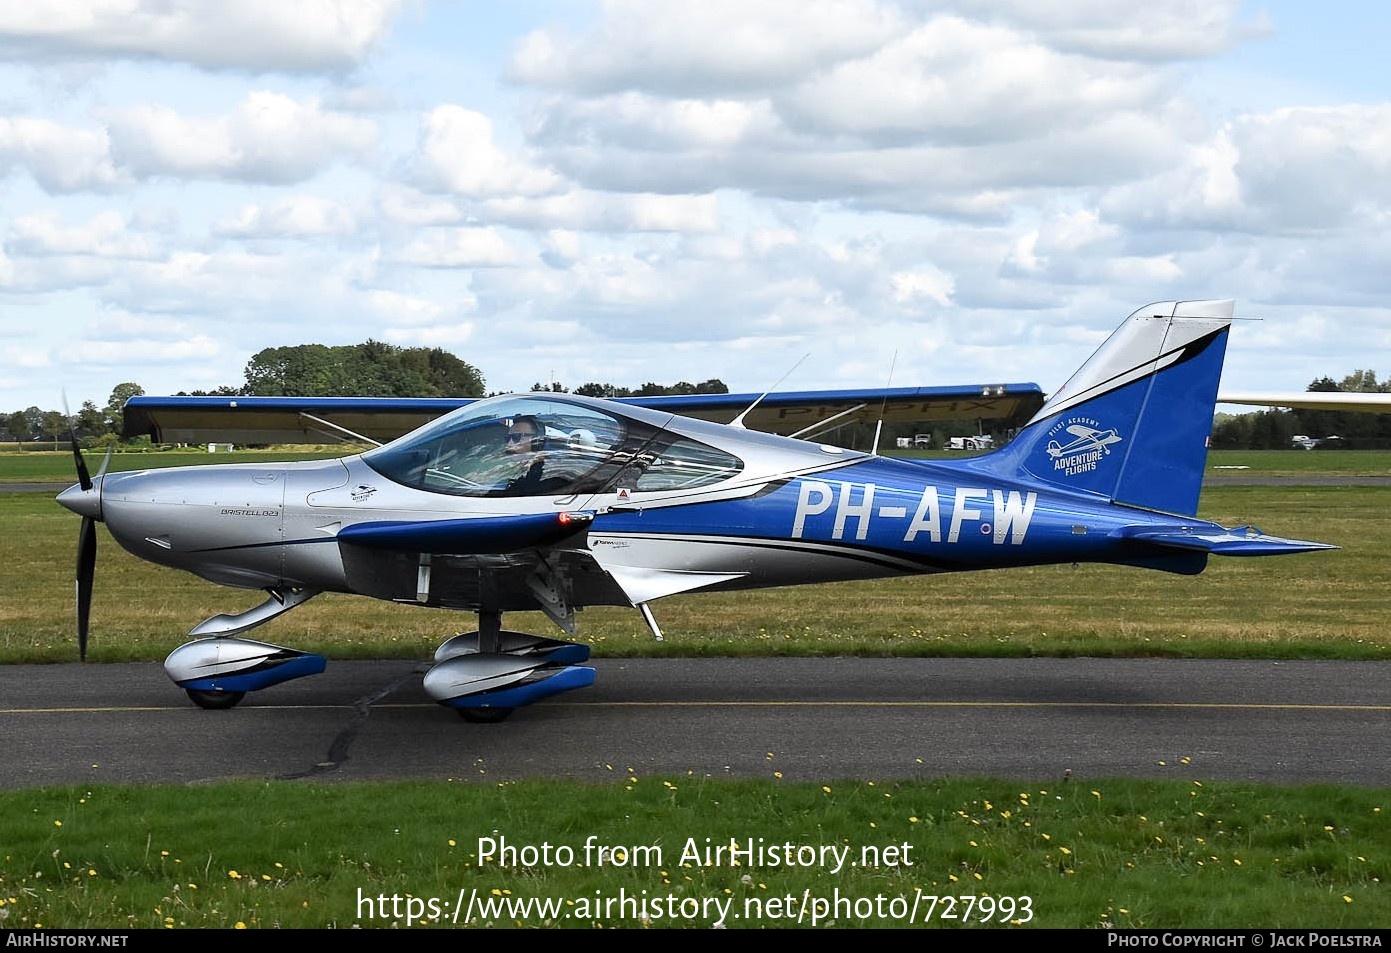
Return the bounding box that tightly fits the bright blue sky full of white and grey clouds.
[0,0,1391,413]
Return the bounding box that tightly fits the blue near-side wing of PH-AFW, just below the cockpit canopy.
[338,512,594,555]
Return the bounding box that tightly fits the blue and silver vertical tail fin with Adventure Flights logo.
[979,301,1234,516]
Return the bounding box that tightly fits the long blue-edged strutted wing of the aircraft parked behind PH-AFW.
[121,384,1043,444]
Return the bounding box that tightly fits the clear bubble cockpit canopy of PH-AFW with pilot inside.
[363,397,743,497]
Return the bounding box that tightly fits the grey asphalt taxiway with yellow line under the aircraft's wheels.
[0,658,1391,789]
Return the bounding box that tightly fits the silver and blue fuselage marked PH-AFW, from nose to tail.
[65,395,1212,608]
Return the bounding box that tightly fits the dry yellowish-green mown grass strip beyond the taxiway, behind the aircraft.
[0,467,1391,662]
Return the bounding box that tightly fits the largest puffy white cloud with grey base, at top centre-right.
[519,4,1198,220]
